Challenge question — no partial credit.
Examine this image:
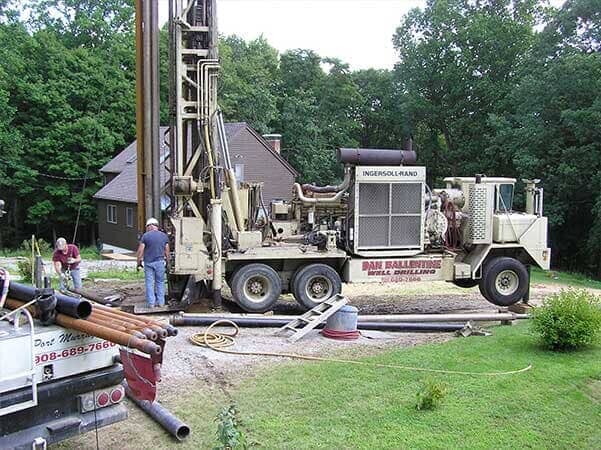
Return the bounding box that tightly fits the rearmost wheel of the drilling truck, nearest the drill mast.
[230,264,282,312]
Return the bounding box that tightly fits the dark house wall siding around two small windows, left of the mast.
[96,200,138,251]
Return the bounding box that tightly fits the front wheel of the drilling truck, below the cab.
[480,257,530,306]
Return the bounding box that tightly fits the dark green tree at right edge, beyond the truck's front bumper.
[490,0,601,276]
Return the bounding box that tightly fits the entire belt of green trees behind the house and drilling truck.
[0,0,601,277]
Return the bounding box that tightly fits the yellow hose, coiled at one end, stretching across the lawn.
[190,320,532,377]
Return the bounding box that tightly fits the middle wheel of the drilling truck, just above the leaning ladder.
[292,264,342,309]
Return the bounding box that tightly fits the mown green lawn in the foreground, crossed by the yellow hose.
[120,324,601,449]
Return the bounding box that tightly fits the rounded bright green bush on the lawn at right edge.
[531,289,601,351]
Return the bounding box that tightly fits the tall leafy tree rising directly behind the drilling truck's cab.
[394,0,537,176]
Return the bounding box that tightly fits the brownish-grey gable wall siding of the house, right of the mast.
[229,128,294,203]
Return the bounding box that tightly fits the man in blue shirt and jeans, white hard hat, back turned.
[138,218,169,308]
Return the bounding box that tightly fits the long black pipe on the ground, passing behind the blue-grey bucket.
[169,315,464,332]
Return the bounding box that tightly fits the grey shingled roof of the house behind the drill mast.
[94,122,298,203]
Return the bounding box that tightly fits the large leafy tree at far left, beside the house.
[0,1,135,243]
